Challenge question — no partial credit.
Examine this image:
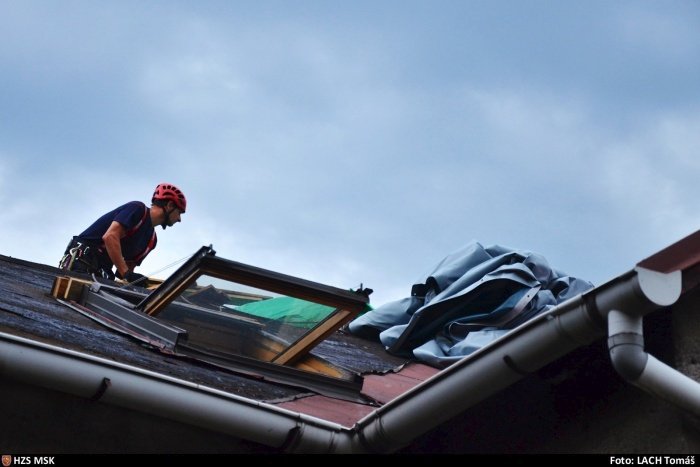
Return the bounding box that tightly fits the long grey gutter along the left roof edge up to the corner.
[0,333,350,452]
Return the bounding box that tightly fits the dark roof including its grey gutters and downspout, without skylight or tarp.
[0,229,700,452]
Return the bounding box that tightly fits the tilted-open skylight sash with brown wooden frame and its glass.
[136,247,368,365]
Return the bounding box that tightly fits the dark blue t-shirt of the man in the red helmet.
[75,201,157,264]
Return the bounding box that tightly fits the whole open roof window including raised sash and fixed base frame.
[52,247,404,399]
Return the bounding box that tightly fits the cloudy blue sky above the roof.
[0,0,700,306]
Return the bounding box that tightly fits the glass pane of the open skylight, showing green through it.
[159,275,336,361]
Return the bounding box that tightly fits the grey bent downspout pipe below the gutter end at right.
[608,268,700,416]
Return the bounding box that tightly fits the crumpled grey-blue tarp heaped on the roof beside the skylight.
[348,241,593,366]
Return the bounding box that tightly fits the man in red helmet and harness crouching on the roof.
[59,183,187,287]
